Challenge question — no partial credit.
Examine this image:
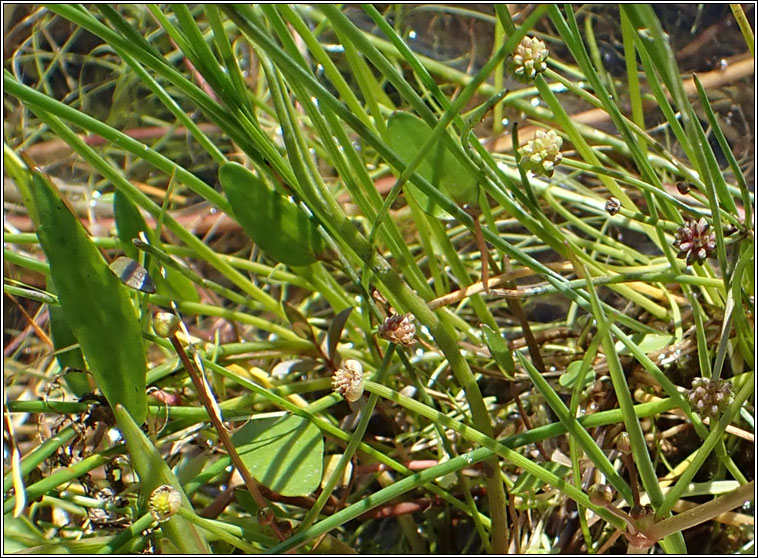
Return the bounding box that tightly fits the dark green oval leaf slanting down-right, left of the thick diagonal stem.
[218,163,325,266]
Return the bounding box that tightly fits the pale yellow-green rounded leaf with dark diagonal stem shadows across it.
[232,415,324,496]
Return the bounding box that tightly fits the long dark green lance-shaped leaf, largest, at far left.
[32,172,147,423]
